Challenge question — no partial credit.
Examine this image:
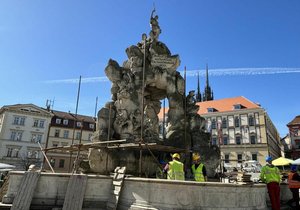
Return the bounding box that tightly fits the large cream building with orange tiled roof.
[197,96,282,167]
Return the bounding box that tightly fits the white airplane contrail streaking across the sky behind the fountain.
[45,67,300,84]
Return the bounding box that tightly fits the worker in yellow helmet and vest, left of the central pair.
[163,153,184,180]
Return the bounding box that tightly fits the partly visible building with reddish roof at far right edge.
[287,115,300,159]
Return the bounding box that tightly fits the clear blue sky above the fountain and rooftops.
[0,0,300,137]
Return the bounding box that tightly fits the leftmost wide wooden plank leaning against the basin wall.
[11,171,40,210]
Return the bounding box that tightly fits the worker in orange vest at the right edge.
[288,165,300,209]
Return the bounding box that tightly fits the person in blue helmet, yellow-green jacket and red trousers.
[260,156,280,210]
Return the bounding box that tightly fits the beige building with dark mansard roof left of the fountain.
[45,110,96,172]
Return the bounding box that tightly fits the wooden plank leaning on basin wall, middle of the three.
[63,174,87,210]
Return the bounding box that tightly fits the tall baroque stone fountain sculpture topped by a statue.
[83,10,220,177]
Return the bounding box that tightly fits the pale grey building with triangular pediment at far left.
[0,104,52,170]
